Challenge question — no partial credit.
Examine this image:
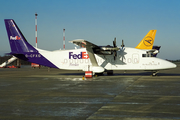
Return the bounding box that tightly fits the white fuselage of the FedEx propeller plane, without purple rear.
[38,47,176,71]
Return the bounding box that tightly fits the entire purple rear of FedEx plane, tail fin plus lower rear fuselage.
[4,19,57,68]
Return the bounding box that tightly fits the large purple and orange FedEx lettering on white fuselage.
[69,52,89,59]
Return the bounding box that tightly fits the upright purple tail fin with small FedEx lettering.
[4,19,38,54]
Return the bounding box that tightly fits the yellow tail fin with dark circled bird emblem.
[136,30,157,49]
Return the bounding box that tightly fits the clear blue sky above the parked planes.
[0,0,180,60]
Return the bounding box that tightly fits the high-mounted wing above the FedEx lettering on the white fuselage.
[69,39,99,48]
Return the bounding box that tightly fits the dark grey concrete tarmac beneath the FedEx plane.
[0,63,180,120]
